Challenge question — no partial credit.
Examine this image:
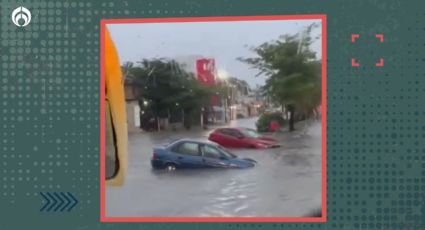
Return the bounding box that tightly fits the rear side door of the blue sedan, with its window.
[171,141,203,168]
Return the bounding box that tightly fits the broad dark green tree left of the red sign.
[123,59,214,128]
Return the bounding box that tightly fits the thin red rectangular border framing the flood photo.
[100,14,327,222]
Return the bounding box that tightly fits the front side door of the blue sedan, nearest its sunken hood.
[201,144,230,168]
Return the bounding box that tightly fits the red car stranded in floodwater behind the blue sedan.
[208,128,280,149]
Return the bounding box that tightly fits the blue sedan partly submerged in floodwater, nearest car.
[151,139,256,171]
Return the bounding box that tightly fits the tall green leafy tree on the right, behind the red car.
[238,23,321,131]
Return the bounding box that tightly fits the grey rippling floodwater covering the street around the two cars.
[106,118,322,217]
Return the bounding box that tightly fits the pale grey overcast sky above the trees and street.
[107,20,322,86]
